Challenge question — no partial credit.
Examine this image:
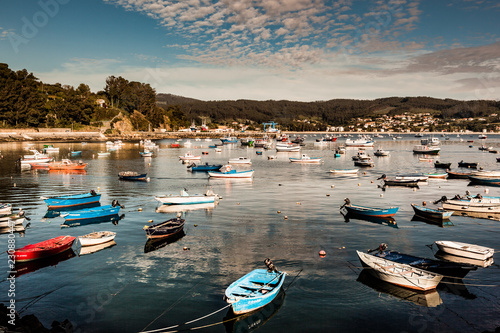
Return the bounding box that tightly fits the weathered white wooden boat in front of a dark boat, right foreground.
[356,251,443,291]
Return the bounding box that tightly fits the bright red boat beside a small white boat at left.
[14,236,76,262]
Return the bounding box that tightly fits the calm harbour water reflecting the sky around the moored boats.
[0,136,500,332]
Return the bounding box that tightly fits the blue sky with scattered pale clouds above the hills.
[0,0,500,102]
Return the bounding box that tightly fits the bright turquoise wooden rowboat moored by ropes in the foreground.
[224,259,286,315]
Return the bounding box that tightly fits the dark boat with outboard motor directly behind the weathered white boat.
[369,243,477,279]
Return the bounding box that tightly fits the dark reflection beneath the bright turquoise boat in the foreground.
[223,289,285,332]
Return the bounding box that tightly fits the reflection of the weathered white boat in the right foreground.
[356,270,443,308]
